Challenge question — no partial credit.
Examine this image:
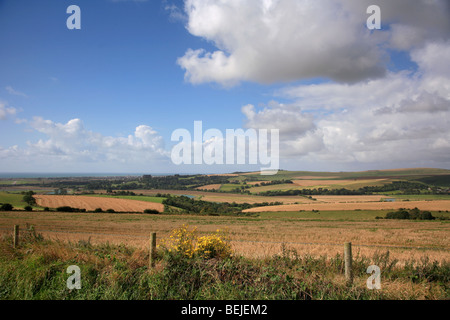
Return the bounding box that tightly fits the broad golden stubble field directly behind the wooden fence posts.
[0,212,450,262]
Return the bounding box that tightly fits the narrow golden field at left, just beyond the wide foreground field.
[34,195,164,212]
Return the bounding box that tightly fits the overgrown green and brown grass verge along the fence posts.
[0,228,450,300]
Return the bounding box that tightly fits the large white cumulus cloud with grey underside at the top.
[178,0,450,86]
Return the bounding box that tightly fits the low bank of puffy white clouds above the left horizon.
[0,117,168,168]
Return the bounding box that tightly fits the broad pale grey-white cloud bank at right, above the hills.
[251,42,450,166]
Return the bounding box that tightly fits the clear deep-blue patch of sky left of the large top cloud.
[0,1,264,138]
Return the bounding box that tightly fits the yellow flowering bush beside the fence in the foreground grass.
[163,225,232,259]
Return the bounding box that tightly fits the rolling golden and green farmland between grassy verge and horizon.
[0,169,450,299]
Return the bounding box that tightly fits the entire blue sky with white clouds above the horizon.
[0,0,450,173]
